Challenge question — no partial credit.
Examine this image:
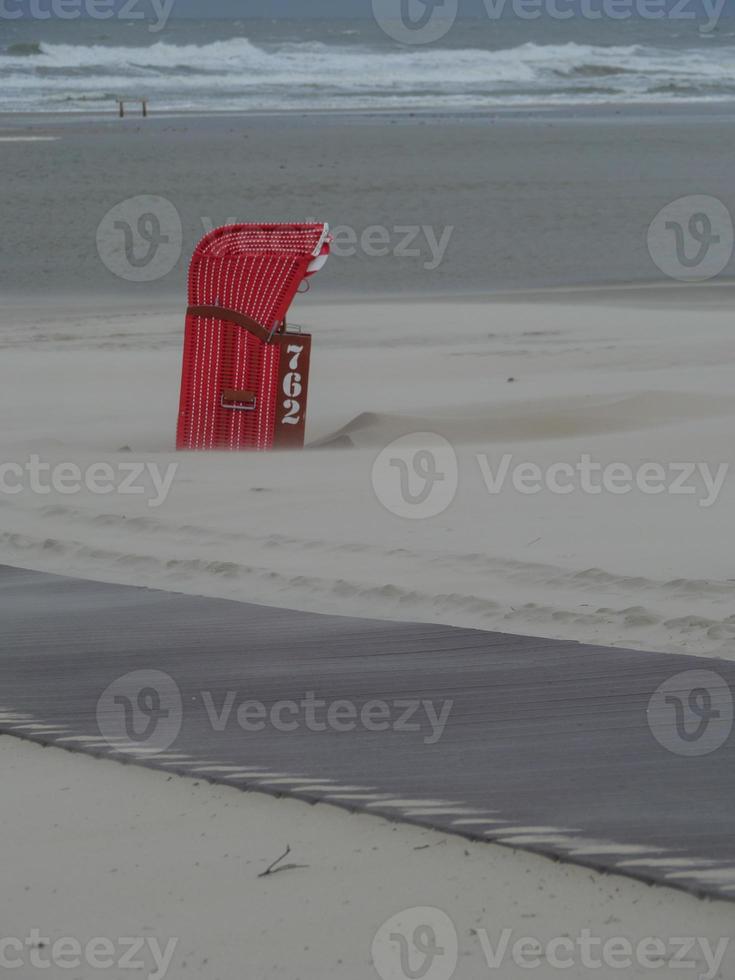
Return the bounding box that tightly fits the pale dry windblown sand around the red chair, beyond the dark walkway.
[0,287,735,659]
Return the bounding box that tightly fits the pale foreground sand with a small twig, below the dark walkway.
[0,737,735,980]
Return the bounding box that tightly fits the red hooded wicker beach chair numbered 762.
[176,224,330,449]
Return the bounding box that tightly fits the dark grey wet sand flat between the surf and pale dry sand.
[0,104,735,301]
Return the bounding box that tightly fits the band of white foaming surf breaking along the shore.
[0,36,735,108]
